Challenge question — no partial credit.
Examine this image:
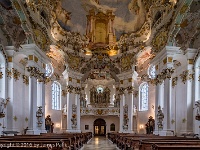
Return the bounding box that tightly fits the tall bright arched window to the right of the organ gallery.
[139,83,149,111]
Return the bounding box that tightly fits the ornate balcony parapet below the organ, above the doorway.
[81,107,119,116]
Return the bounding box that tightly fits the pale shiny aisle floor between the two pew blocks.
[83,137,117,150]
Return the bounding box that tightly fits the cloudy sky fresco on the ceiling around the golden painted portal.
[59,0,146,40]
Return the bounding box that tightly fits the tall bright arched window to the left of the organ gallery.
[52,81,61,110]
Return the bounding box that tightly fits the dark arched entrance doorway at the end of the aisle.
[94,118,106,136]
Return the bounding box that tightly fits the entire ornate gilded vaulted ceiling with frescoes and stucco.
[0,0,200,82]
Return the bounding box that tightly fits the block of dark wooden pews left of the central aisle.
[0,132,92,150]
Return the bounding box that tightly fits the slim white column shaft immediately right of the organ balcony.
[119,94,124,133]
